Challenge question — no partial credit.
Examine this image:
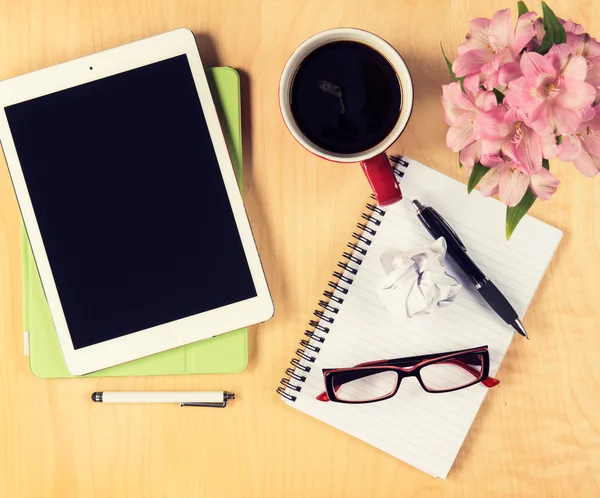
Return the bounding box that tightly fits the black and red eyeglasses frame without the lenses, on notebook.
[317,346,500,404]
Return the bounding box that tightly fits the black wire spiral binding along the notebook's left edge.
[277,156,408,402]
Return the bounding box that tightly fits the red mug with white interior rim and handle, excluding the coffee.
[279,28,414,206]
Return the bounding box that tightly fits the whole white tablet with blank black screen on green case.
[0,29,273,375]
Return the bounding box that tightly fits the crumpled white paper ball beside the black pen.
[378,237,462,318]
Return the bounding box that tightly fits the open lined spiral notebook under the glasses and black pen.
[278,158,562,478]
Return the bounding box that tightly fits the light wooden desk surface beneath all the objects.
[0,0,600,498]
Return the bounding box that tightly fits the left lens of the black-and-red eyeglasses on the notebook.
[333,370,398,402]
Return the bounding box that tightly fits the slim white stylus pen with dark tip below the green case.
[92,391,235,408]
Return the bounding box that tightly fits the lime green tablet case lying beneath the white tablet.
[21,67,248,379]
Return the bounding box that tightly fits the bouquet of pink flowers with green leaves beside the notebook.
[442,2,600,238]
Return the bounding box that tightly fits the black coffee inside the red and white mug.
[290,41,402,154]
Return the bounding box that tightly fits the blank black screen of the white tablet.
[6,55,257,349]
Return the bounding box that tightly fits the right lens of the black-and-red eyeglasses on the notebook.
[421,353,483,392]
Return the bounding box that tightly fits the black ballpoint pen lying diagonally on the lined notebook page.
[412,200,529,339]
